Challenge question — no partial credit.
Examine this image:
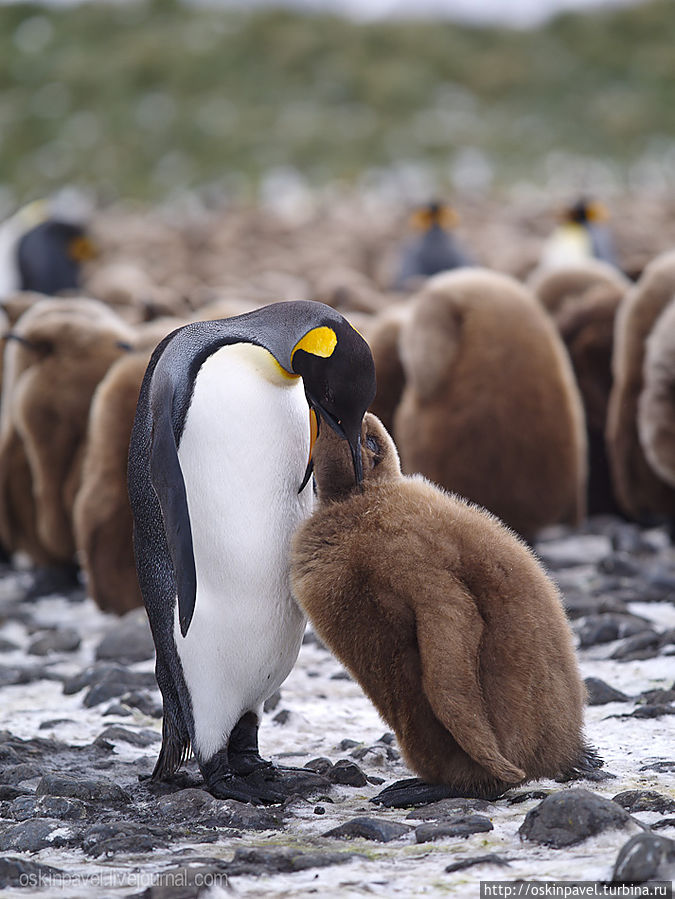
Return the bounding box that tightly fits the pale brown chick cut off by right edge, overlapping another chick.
[638,295,675,487]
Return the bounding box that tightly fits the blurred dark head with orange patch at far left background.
[17,220,94,295]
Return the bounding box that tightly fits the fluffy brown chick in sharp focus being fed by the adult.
[291,413,598,798]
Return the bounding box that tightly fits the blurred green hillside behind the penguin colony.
[0,0,675,200]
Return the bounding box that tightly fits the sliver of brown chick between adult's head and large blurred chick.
[366,303,411,431]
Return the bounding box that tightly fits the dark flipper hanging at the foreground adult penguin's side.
[150,366,197,636]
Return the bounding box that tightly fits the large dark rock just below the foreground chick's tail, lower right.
[518,789,631,849]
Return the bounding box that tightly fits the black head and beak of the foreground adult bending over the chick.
[291,310,375,484]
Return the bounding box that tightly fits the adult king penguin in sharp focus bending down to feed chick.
[129,302,375,803]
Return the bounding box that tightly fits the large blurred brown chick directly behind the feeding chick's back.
[394,269,586,538]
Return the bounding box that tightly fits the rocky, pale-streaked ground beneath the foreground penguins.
[0,519,675,899]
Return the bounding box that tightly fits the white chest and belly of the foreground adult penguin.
[174,344,312,757]
